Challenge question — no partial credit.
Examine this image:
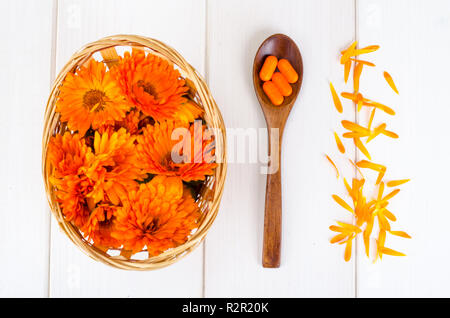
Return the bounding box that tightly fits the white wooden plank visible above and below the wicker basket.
[50,0,205,297]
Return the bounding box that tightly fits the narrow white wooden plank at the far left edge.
[0,0,53,297]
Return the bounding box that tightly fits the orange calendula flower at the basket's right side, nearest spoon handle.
[136,121,216,181]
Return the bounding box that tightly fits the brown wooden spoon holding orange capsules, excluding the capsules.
[253,34,303,268]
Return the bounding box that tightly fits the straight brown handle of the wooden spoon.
[262,135,281,268]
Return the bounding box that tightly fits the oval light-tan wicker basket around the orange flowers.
[42,35,227,270]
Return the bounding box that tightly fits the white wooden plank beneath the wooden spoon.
[205,0,355,297]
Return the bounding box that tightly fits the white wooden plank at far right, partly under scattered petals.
[357,0,450,297]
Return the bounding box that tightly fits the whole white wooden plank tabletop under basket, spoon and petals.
[0,0,450,297]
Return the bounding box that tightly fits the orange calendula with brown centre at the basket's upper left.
[56,59,130,135]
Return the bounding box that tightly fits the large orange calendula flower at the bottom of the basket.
[111,176,200,256]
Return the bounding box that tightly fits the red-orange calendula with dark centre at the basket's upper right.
[112,49,188,120]
